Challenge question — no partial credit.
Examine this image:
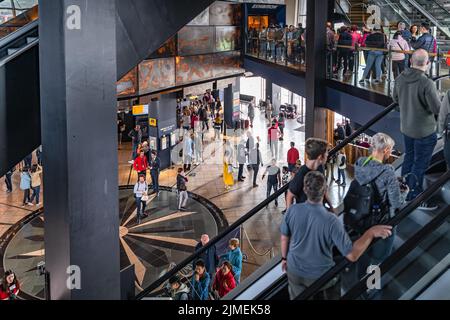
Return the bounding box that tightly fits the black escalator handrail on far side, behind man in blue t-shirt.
[136,103,397,300]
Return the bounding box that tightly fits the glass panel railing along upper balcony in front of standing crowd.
[246,30,450,96]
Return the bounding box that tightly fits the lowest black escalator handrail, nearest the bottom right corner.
[341,201,450,300]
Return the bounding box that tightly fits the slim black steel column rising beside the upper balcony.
[305,0,328,138]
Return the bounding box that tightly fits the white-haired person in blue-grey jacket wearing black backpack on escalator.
[344,133,402,264]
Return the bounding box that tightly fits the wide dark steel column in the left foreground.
[39,0,120,299]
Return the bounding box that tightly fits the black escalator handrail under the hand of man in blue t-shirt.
[295,171,450,300]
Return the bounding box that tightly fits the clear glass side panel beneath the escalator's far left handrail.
[137,99,414,299]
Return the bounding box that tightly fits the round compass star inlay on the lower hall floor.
[0,187,228,299]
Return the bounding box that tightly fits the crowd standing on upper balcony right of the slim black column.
[327,22,437,84]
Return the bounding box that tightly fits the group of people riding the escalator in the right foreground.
[281,49,450,299]
